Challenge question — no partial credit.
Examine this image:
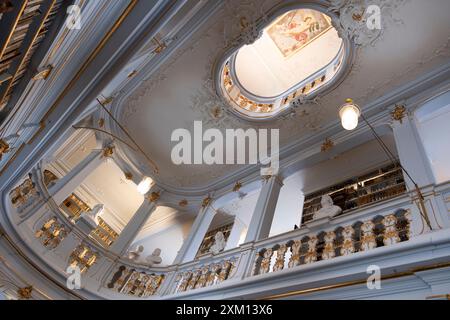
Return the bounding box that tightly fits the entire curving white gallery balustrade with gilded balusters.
[4,165,450,298]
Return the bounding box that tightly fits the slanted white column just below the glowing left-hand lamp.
[110,192,159,256]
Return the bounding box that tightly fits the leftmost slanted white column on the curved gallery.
[49,150,104,205]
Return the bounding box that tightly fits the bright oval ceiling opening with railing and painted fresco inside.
[220,8,345,118]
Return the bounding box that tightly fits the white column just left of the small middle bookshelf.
[174,201,215,264]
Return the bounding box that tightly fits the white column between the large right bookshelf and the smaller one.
[245,176,283,242]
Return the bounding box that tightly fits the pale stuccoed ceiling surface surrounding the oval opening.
[107,0,450,189]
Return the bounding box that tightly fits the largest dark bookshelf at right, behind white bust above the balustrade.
[302,164,406,224]
